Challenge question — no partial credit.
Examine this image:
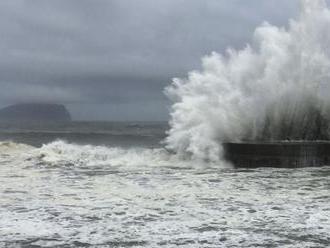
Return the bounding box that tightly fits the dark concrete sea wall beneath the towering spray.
[224,142,330,168]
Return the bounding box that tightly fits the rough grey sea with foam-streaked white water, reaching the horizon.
[0,122,330,248]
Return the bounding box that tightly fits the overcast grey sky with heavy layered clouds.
[0,0,312,121]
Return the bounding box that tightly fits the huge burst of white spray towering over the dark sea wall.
[165,0,330,161]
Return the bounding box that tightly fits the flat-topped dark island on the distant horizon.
[0,103,71,121]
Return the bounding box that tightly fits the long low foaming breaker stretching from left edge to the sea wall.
[0,140,230,170]
